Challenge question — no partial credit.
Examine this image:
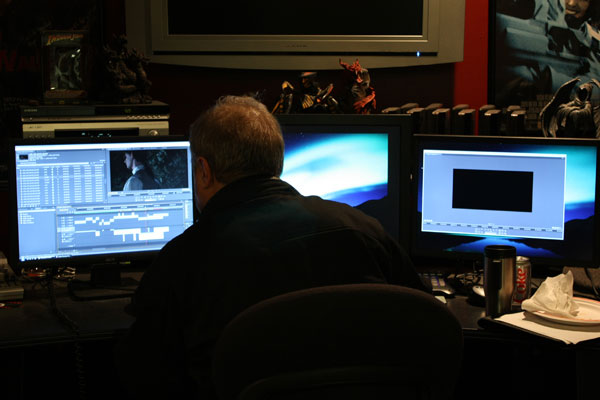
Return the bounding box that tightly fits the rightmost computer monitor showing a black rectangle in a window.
[411,135,599,267]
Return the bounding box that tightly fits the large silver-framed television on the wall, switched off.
[125,0,465,70]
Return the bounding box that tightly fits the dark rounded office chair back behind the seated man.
[213,283,463,400]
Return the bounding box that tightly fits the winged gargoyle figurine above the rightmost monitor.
[540,78,600,138]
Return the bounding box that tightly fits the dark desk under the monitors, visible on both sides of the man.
[0,283,600,400]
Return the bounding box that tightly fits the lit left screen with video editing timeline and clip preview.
[14,139,194,262]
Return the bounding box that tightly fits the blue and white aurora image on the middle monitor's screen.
[281,133,388,207]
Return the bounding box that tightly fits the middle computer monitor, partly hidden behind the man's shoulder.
[277,114,411,244]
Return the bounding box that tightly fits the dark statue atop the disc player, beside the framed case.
[104,35,152,104]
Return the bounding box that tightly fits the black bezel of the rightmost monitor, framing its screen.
[409,134,600,268]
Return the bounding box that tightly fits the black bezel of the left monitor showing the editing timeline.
[8,135,196,271]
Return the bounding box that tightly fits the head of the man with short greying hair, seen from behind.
[190,96,284,209]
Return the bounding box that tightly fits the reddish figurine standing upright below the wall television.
[340,60,376,114]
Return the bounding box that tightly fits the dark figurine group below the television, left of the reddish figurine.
[271,72,339,114]
